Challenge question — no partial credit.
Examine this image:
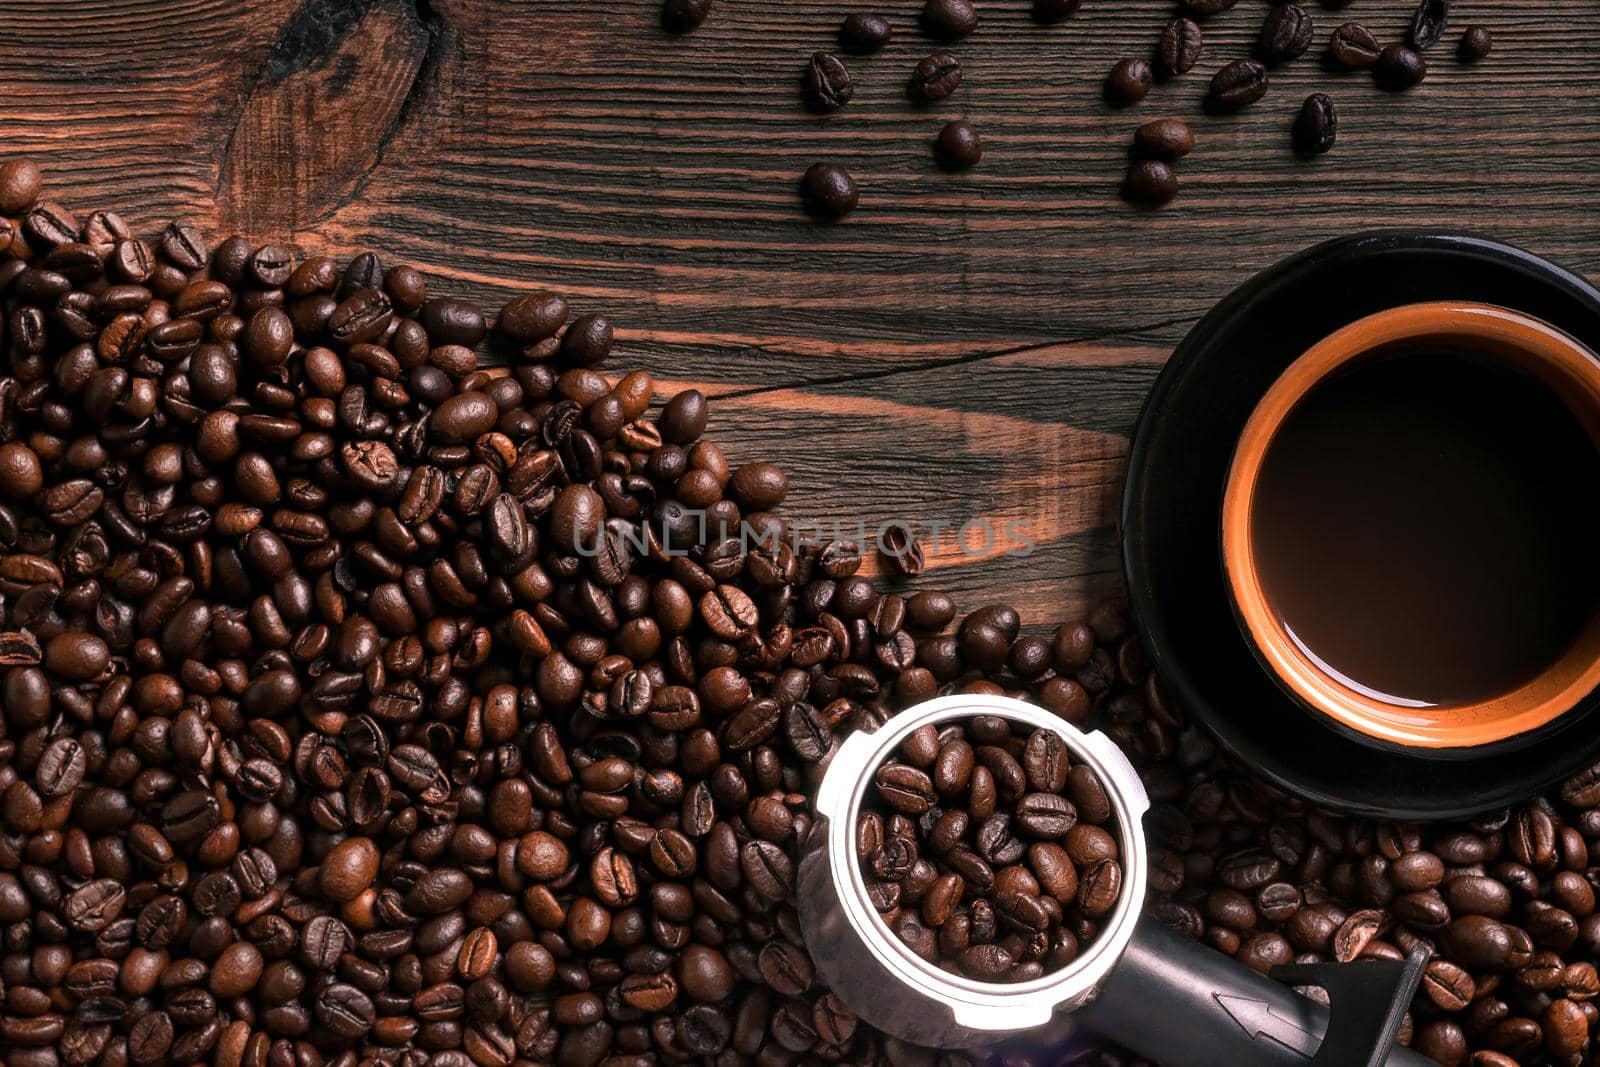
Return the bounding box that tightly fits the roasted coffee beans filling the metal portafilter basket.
[856,715,1122,982]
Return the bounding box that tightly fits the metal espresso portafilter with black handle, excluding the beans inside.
[798,694,1432,1067]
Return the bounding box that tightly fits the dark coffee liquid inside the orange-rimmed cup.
[1251,349,1600,707]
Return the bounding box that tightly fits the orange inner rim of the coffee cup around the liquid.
[1222,301,1600,749]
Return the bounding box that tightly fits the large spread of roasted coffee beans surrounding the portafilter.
[0,154,1600,1067]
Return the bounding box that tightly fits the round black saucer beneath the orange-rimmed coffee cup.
[1122,232,1600,819]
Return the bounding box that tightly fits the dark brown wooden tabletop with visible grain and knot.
[0,0,1600,621]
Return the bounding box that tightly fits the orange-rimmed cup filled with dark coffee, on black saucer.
[1222,302,1600,749]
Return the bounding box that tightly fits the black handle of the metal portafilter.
[1072,918,1435,1067]
